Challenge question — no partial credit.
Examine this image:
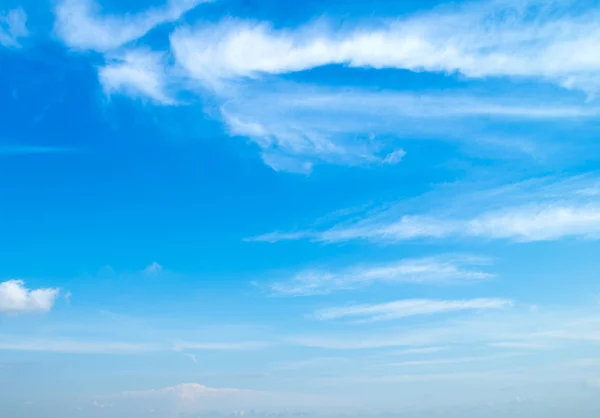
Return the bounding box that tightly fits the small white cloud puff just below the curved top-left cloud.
[98,49,175,105]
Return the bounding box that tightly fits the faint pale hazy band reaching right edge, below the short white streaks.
[287,309,600,350]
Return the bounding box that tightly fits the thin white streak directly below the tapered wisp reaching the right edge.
[268,256,493,296]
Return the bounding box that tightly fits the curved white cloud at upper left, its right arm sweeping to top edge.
[55,0,206,52]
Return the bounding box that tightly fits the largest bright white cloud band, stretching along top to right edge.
[171,0,600,92]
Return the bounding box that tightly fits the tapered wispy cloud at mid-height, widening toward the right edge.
[253,175,600,243]
